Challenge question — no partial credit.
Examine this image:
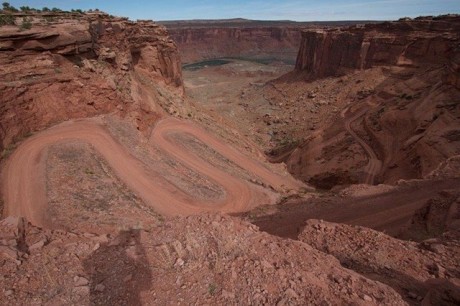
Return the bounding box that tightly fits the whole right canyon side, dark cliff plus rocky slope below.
[264,15,460,188]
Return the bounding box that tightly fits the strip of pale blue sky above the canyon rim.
[2,0,460,21]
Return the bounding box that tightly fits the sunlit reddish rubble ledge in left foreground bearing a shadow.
[0,215,405,305]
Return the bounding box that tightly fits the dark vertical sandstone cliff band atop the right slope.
[296,16,460,78]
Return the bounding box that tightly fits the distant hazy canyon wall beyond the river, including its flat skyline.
[160,18,372,65]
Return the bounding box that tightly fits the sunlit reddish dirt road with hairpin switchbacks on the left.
[2,118,303,226]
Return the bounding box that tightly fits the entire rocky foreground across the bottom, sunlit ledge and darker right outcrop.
[0,210,460,305]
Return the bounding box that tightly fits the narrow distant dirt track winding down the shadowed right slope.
[342,108,382,185]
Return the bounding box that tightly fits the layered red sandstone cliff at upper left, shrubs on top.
[0,15,183,153]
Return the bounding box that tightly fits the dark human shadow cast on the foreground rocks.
[84,230,152,305]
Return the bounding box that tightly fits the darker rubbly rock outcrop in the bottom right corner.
[299,220,460,305]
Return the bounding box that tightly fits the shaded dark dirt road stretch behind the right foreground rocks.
[250,179,460,239]
